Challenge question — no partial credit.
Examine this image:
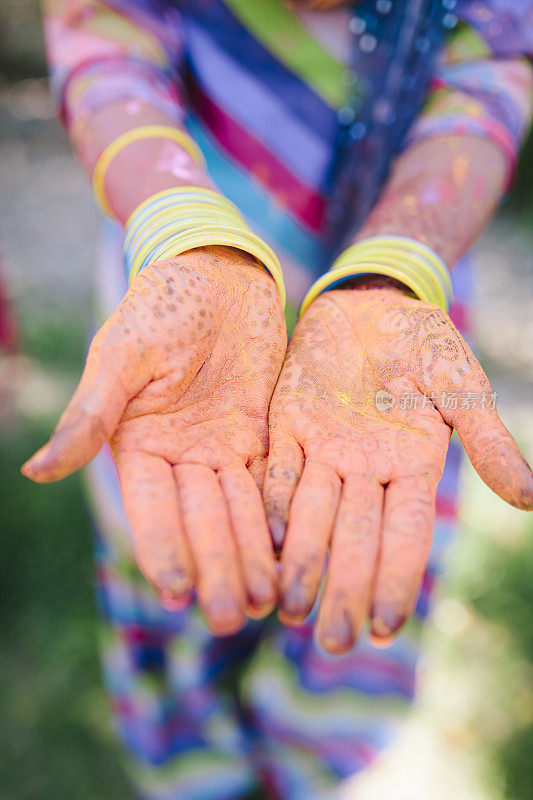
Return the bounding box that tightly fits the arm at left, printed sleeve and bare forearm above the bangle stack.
[41,0,209,222]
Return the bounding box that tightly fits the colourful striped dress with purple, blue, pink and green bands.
[45,0,533,800]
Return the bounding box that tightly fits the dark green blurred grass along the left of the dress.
[0,317,131,800]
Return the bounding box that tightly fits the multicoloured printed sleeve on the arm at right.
[407,0,533,185]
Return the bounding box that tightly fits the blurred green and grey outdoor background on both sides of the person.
[0,0,533,800]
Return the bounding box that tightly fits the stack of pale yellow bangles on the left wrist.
[123,186,285,304]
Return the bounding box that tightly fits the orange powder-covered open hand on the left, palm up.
[22,247,286,634]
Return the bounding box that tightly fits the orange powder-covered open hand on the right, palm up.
[264,288,533,653]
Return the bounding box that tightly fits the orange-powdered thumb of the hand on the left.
[21,321,150,483]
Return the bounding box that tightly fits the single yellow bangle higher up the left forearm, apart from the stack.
[92,125,205,217]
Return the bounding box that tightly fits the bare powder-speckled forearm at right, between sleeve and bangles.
[355,135,506,269]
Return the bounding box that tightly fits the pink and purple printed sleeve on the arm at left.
[43,0,184,130]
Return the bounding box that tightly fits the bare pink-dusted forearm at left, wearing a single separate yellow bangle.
[70,100,212,223]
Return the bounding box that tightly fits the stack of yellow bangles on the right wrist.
[300,236,452,316]
